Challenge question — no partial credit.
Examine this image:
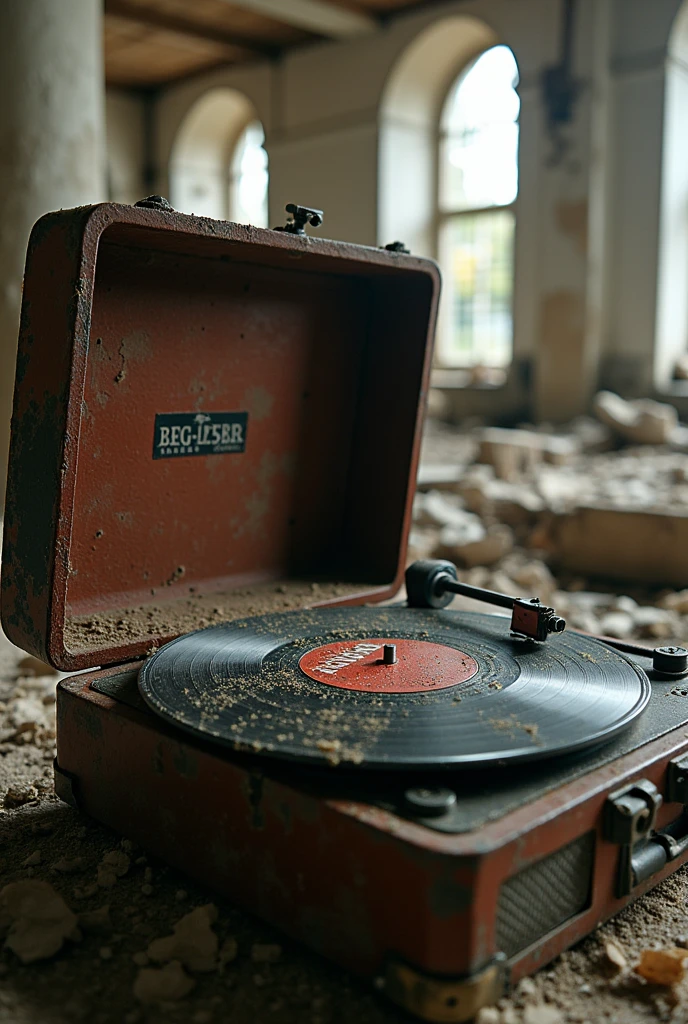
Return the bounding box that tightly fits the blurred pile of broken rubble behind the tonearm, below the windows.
[410,392,688,641]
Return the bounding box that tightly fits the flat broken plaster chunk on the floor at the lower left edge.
[0,880,81,964]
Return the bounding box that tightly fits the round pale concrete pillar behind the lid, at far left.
[0,0,105,499]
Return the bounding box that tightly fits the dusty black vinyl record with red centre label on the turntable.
[139,607,650,769]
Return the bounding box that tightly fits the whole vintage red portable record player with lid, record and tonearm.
[2,197,688,1021]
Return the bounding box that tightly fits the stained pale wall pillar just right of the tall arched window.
[523,0,610,422]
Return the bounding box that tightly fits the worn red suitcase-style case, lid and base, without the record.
[2,195,688,1021]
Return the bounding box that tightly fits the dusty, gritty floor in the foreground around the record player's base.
[0,419,688,1024]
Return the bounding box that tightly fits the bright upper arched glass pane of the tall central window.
[440,46,520,211]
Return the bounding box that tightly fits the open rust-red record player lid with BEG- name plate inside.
[2,204,439,670]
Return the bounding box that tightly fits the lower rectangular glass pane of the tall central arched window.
[439,210,514,367]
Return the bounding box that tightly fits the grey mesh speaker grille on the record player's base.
[497,833,595,956]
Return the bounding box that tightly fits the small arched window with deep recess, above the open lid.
[170,88,268,227]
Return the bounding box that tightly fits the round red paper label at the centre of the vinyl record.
[299,638,478,693]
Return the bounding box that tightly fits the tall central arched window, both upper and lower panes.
[438,46,520,367]
